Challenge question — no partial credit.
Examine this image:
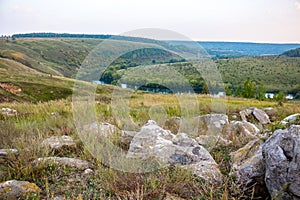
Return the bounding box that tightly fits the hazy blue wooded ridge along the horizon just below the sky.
[12,33,300,58]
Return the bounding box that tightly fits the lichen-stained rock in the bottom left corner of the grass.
[0,180,41,199]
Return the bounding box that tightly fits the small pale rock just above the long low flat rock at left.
[42,135,76,150]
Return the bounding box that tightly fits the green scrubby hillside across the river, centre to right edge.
[110,56,300,94]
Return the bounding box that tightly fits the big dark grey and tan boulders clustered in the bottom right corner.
[231,125,300,200]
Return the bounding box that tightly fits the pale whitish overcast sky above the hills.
[0,0,300,43]
